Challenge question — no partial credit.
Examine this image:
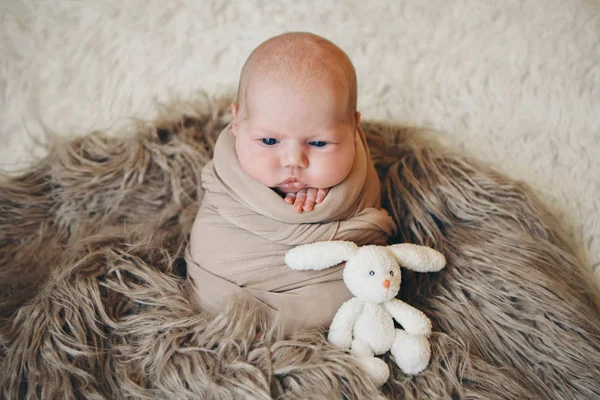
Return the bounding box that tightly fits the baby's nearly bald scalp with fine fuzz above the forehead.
[237,32,357,116]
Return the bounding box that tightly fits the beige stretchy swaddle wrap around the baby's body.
[186,126,396,332]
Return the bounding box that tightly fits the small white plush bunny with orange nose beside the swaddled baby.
[285,241,446,386]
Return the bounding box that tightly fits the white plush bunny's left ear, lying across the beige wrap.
[285,240,358,270]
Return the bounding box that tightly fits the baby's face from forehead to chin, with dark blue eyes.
[232,77,360,193]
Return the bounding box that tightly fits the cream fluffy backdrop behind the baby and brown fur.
[0,0,600,277]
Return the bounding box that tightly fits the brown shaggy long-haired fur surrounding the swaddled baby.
[0,95,600,399]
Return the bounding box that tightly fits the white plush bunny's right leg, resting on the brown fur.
[390,329,431,375]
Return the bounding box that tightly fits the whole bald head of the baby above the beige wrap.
[232,33,360,193]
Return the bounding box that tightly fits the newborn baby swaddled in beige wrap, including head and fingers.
[186,33,396,333]
